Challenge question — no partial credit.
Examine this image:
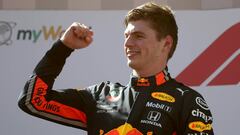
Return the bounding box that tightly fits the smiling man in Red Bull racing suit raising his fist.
[19,3,213,135]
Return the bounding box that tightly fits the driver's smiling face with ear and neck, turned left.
[124,20,172,76]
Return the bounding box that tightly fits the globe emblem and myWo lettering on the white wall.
[0,21,65,45]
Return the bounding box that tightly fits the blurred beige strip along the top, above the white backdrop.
[0,0,240,10]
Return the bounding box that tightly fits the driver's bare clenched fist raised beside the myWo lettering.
[60,22,93,49]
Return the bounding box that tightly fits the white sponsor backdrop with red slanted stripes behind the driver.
[0,9,240,135]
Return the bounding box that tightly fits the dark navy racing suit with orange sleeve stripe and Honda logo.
[18,40,213,135]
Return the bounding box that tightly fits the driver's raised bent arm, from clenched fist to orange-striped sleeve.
[18,23,93,129]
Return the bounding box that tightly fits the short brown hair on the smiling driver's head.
[124,2,178,59]
